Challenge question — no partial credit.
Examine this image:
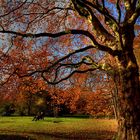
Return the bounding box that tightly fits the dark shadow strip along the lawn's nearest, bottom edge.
[0,131,116,140]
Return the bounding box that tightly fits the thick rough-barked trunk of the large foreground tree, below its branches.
[117,52,140,140]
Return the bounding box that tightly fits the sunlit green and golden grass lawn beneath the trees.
[0,117,117,140]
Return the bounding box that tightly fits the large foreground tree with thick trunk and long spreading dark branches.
[0,0,140,140]
